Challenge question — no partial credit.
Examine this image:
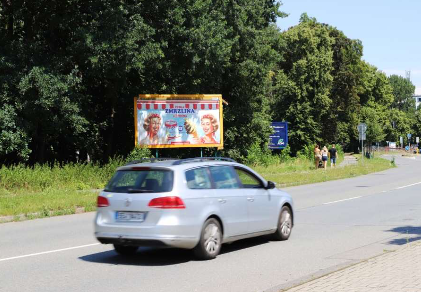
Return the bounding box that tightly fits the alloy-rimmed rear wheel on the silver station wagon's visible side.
[193,218,222,260]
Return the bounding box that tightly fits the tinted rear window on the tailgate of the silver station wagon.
[104,169,174,193]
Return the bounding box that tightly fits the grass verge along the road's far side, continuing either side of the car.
[0,157,394,223]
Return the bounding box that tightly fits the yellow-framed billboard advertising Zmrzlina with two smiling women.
[134,94,223,149]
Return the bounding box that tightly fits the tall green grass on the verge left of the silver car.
[0,158,124,218]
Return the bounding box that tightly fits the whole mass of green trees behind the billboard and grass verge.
[0,0,421,164]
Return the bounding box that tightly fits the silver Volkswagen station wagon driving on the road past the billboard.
[95,157,294,259]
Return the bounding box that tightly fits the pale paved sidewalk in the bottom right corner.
[280,241,421,292]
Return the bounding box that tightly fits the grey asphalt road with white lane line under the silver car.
[0,157,421,292]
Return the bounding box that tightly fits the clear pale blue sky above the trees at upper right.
[277,0,421,94]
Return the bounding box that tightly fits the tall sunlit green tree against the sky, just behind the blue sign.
[274,14,333,152]
